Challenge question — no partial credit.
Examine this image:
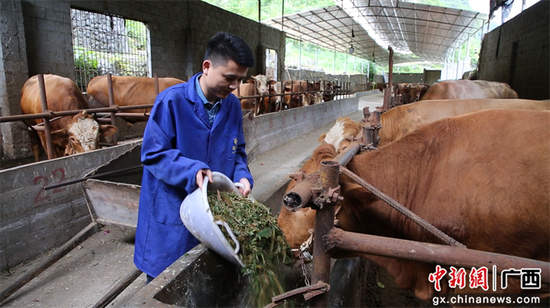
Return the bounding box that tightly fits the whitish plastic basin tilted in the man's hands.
[180,171,248,267]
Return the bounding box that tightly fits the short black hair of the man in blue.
[204,32,254,67]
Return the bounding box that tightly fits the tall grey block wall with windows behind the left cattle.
[0,0,285,160]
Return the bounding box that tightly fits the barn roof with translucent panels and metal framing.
[262,0,488,64]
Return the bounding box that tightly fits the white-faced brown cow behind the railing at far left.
[21,74,117,161]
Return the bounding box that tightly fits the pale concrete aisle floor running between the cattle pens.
[0,93,383,308]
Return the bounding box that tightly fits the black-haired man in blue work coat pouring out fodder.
[134,32,254,281]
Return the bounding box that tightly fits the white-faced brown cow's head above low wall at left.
[52,111,117,156]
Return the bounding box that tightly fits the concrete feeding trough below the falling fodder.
[125,244,368,308]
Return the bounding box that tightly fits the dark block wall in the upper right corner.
[478,1,550,99]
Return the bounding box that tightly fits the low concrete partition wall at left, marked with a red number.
[0,143,141,271]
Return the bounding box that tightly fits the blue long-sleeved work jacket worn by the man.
[134,74,253,277]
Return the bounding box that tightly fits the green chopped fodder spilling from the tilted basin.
[208,191,292,307]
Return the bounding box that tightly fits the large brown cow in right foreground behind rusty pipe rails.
[280,109,550,300]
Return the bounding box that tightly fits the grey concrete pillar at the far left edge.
[0,0,32,160]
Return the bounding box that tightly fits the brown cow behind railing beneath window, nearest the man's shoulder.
[86,75,184,123]
